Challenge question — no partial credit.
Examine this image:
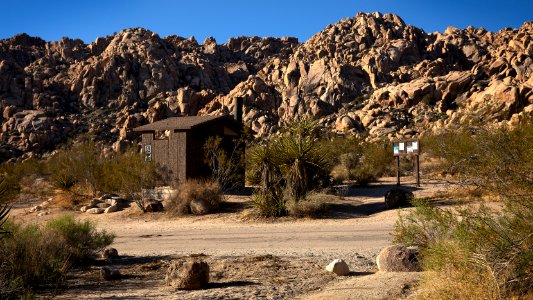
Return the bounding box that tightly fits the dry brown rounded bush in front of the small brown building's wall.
[165,180,223,215]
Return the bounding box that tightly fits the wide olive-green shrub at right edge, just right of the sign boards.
[422,119,533,198]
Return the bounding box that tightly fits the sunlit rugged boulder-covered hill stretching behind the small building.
[0,13,533,161]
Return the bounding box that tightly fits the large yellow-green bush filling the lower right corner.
[394,199,533,299]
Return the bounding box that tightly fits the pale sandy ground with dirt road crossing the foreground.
[13,178,448,299]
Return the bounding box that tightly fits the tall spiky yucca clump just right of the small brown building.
[249,119,332,217]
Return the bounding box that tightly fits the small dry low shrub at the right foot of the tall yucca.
[287,192,332,218]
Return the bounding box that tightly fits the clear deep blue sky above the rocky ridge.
[0,0,533,43]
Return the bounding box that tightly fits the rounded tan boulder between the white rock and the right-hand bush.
[376,245,422,272]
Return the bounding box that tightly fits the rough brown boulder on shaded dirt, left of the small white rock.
[165,260,209,290]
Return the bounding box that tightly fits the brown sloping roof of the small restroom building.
[133,115,242,132]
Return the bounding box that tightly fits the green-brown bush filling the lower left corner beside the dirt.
[0,216,114,298]
